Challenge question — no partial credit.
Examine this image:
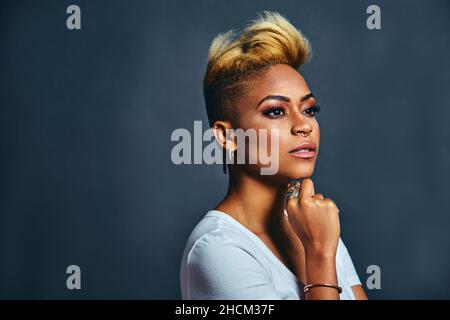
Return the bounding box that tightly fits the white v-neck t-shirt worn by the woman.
[180,210,361,300]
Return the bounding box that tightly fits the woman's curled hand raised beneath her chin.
[286,178,340,257]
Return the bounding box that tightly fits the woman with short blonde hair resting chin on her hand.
[180,12,366,299]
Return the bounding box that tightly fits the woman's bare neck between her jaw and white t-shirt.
[216,171,286,234]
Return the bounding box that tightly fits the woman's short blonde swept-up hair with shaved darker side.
[203,11,311,124]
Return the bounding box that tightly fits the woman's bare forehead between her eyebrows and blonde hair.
[244,64,310,102]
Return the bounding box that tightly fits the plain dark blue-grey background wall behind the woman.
[0,0,450,299]
